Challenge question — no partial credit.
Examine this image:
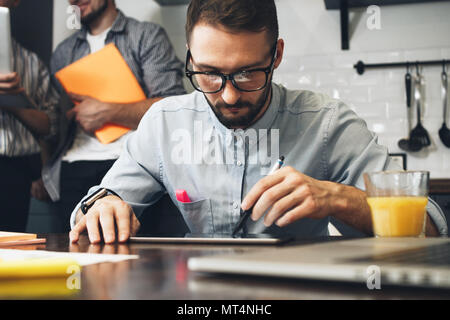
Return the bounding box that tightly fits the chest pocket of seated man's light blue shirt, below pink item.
[177,199,214,233]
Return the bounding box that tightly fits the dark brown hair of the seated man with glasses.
[186,0,278,44]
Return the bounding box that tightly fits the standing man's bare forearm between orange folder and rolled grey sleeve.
[110,98,162,130]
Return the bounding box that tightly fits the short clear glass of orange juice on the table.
[364,171,430,237]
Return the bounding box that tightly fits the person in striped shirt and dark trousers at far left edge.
[0,0,59,231]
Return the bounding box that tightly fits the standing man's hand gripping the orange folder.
[66,93,117,133]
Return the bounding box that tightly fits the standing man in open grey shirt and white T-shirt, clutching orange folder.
[43,0,186,231]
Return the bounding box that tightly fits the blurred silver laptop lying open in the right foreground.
[188,238,450,289]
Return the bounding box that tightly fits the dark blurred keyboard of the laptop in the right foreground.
[352,242,450,267]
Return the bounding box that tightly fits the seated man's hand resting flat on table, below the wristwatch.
[69,195,140,243]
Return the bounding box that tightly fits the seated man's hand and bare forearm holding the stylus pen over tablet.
[242,167,372,234]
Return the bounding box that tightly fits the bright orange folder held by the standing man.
[55,43,147,144]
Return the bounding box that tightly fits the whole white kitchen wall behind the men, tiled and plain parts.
[53,0,450,178]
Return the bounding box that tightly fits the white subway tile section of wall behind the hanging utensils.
[274,48,450,178]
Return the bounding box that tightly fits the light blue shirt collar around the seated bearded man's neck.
[204,83,280,136]
